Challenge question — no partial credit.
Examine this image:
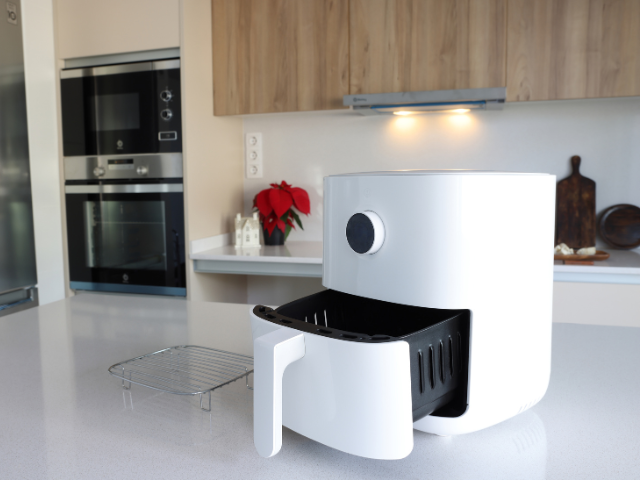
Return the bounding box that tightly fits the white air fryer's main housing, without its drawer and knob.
[323,171,555,435]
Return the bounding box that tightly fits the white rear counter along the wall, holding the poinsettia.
[190,237,640,285]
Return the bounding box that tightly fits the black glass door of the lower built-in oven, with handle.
[65,183,187,296]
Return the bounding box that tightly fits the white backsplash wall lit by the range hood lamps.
[244,97,640,241]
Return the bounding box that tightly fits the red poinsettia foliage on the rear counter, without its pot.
[253,180,311,239]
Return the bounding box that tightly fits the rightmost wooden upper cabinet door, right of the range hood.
[507,0,640,101]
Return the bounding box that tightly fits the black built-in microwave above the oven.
[60,59,182,157]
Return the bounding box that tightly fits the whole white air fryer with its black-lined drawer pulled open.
[252,170,556,459]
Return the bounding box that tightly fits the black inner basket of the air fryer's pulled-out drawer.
[253,290,470,421]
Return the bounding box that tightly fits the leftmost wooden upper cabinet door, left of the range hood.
[212,0,349,115]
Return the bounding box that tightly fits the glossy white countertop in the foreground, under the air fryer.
[0,294,640,480]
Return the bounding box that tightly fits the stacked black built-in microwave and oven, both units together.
[61,59,186,296]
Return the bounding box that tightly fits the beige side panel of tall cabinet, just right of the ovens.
[180,0,247,303]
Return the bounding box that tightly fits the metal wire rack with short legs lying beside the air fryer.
[109,345,253,412]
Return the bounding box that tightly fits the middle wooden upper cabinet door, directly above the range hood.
[349,0,506,94]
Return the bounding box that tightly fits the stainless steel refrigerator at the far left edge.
[0,1,38,316]
